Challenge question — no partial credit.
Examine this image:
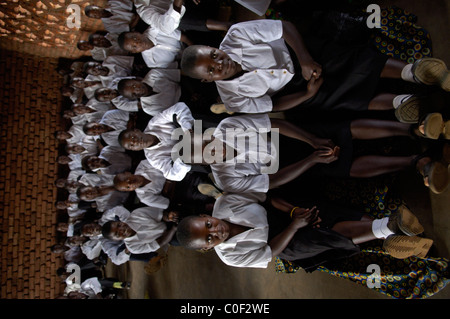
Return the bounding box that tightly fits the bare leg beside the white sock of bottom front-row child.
[331,216,377,245]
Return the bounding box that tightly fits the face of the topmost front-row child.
[195,46,237,82]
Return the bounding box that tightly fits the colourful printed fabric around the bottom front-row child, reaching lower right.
[275,177,449,299]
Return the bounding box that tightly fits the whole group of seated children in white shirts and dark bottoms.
[54,0,450,298]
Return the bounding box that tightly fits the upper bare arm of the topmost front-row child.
[282,21,322,81]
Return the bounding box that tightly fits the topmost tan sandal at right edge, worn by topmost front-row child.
[411,58,450,92]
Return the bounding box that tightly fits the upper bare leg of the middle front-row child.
[350,119,410,140]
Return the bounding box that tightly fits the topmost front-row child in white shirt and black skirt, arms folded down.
[181,20,449,118]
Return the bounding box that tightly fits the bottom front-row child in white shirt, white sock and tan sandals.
[177,193,433,269]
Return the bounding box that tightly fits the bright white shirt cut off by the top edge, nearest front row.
[134,0,186,34]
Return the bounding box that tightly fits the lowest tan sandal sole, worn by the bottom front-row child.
[383,235,433,259]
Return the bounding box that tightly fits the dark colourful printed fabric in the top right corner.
[373,6,432,63]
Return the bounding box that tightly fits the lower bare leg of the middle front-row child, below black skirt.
[350,155,416,178]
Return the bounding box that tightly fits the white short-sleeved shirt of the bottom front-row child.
[212,193,272,268]
